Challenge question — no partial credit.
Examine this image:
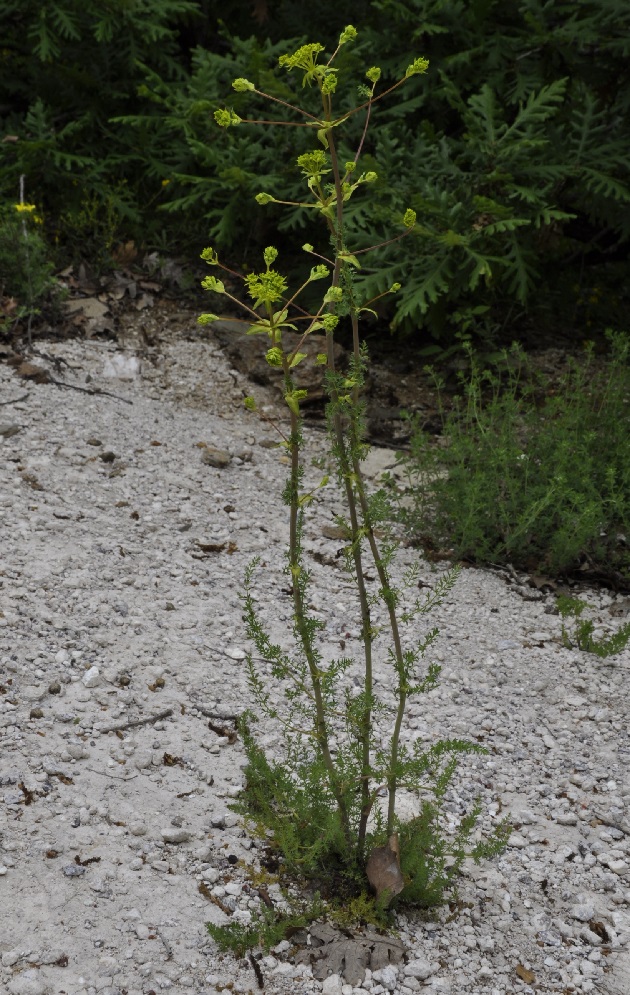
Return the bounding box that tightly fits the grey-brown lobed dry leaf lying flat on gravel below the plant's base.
[295,923,405,986]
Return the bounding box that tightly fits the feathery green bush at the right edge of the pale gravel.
[402,333,630,584]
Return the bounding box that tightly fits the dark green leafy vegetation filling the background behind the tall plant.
[0,0,630,354]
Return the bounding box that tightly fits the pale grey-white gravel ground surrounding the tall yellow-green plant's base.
[0,330,630,995]
